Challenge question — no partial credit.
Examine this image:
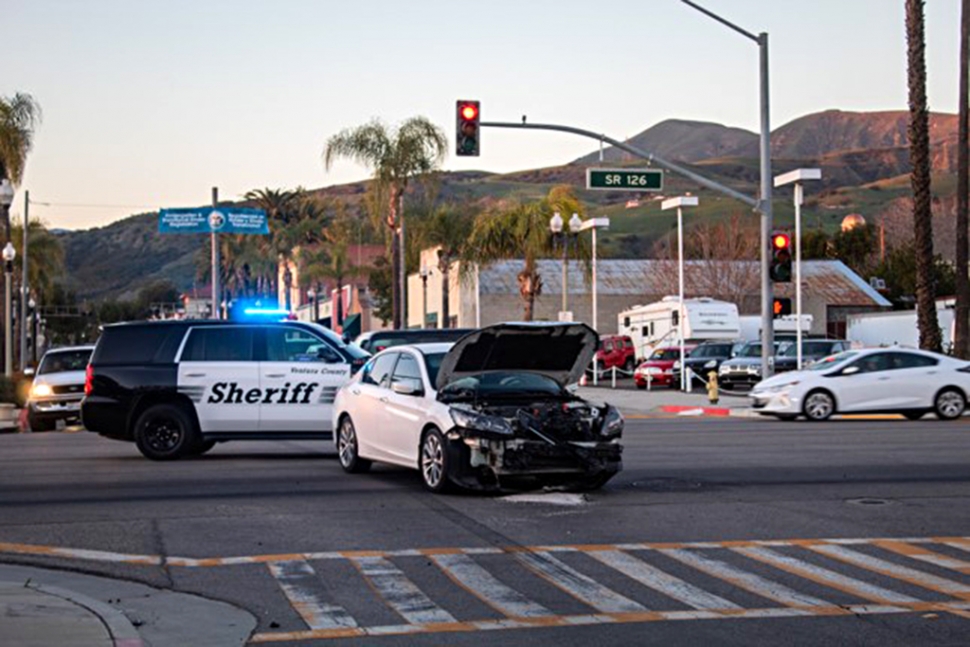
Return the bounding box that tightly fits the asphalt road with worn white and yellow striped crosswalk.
[0,418,970,646]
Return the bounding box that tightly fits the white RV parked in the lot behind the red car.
[617,297,741,360]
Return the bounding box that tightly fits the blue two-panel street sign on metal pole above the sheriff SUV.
[158,200,269,319]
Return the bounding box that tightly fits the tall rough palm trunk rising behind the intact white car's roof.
[906,0,940,351]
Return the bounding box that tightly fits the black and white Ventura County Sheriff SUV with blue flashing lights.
[81,320,368,460]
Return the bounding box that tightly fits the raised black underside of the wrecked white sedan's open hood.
[436,323,598,391]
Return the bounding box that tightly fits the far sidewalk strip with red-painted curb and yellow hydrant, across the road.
[576,381,758,417]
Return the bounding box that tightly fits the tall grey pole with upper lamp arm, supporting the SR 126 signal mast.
[681,0,775,379]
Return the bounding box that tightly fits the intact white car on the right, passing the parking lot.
[749,348,970,420]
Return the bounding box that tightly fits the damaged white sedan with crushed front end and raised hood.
[334,323,623,492]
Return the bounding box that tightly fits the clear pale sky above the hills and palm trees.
[0,0,959,228]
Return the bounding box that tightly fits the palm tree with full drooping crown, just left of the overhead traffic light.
[323,117,448,328]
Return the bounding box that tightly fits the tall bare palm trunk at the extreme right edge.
[953,0,970,359]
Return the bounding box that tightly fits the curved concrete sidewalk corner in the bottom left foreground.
[0,564,256,647]
